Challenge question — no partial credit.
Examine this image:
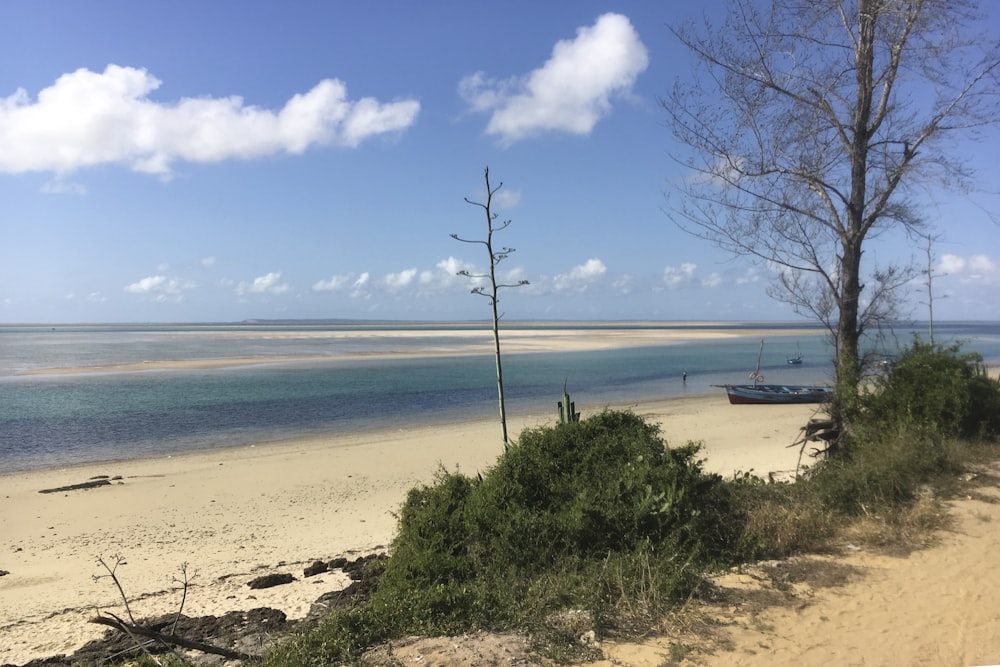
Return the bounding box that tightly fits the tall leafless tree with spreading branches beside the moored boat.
[661,0,1000,448]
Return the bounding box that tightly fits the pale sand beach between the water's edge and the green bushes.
[0,394,816,664]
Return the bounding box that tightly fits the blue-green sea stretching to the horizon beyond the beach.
[0,322,1000,474]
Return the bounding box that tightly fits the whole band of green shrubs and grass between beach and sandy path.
[265,376,1000,667]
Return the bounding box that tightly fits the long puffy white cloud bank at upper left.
[0,65,420,177]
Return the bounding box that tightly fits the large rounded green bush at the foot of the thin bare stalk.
[362,411,739,633]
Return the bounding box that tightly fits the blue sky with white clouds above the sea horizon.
[0,0,1000,323]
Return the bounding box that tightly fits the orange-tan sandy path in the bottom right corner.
[591,480,1000,667]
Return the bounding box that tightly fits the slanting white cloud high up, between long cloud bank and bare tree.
[459,13,649,143]
